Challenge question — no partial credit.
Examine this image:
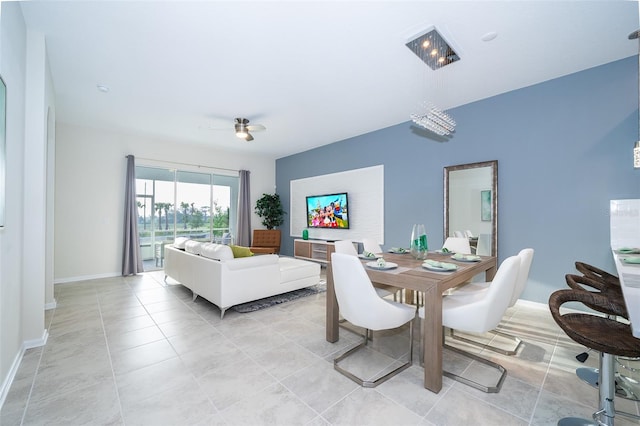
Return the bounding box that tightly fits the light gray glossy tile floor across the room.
[0,271,640,426]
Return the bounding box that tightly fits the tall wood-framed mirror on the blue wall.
[444,160,498,256]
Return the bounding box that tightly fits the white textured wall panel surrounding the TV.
[289,165,384,244]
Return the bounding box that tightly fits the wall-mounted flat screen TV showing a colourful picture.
[307,192,349,229]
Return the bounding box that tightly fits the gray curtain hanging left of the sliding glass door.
[122,155,144,276]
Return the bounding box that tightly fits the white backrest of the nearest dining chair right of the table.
[466,256,520,333]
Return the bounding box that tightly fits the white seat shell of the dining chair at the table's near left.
[331,253,415,330]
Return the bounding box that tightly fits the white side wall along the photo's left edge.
[0,2,50,404]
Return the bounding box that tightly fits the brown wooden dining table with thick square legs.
[326,252,497,393]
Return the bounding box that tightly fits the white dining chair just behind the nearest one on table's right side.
[450,248,534,355]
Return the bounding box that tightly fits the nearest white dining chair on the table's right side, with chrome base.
[418,256,520,393]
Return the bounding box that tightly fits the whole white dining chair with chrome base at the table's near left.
[331,253,416,388]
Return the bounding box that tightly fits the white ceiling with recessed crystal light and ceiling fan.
[21,0,639,158]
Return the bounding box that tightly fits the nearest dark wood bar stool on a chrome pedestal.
[549,289,640,426]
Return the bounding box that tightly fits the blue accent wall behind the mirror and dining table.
[276,56,640,303]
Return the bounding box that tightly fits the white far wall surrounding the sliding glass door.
[54,123,275,283]
